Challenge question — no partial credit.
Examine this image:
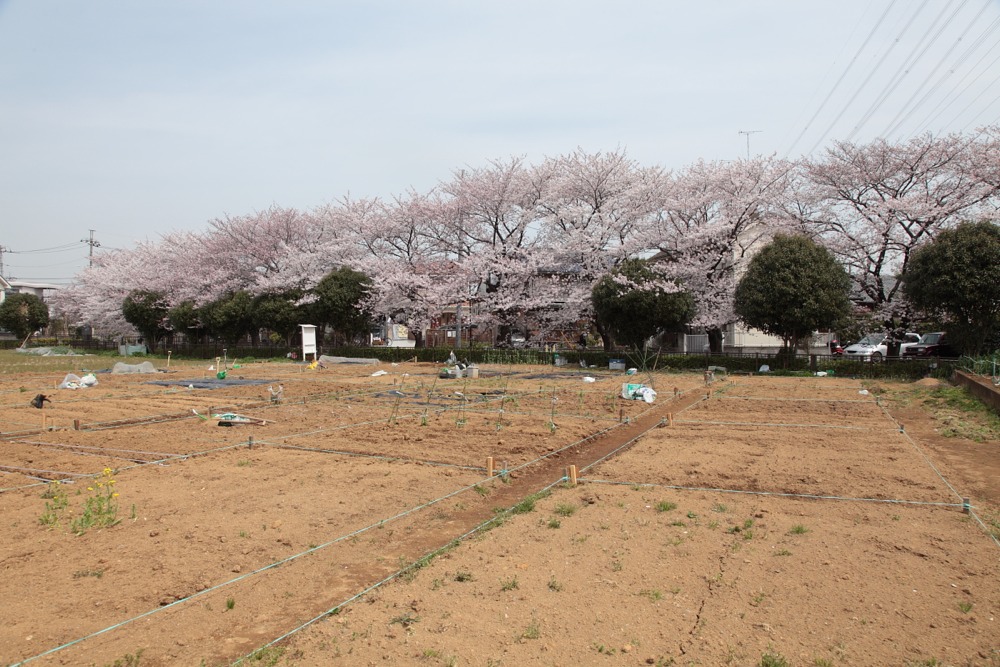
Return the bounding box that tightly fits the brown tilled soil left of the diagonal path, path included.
[0,364,694,664]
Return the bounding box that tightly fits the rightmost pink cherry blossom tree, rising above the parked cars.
[802,133,1000,328]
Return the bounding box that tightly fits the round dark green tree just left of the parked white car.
[734,234,851,356]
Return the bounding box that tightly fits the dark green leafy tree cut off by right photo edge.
[901,222,1000,354]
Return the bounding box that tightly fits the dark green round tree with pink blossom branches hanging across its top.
[591,259,694,350]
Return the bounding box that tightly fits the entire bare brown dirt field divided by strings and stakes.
[0,357,1000,667]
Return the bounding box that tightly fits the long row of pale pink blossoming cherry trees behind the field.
[50,132,1000,349]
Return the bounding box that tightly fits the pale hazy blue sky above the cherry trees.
[0,0,1000,285]
